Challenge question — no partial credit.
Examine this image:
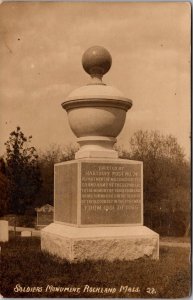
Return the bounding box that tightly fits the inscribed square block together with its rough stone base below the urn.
[41,158,159,261]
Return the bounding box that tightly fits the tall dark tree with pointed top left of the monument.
[5,126,42,213]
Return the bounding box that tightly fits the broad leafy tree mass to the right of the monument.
[119,130,190,235]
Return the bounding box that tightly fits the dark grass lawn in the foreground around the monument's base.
[1,237,191,298]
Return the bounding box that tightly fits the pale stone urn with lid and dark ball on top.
[62,46,132,159]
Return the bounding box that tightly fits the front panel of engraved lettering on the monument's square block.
[81,163,142,224]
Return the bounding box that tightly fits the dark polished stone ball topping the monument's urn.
[82,46,112,76]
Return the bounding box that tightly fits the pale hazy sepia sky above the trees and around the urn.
[0,2,191,158]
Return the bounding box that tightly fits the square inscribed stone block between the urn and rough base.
[54,159,143,227]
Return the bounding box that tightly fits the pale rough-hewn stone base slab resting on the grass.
[41,223,159,262]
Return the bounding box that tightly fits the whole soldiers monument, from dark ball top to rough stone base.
[41,46,159,261]
